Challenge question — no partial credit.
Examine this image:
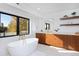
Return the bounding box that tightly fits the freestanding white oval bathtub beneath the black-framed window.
[8,38,38,56]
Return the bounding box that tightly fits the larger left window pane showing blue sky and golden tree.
[0,14,17,36]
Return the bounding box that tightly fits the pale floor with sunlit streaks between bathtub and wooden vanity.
[30,44,79,56]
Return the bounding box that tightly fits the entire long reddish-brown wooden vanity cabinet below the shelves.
[36,33,79,51]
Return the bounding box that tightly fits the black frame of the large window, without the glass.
[0,11,30,38]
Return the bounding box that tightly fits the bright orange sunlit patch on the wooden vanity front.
[46,34,63,47]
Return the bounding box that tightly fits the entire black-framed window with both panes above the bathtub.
[0,12,29,37]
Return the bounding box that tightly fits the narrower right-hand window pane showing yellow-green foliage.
[19,18,29,35]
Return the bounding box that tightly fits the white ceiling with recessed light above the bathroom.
[9,3,79,18]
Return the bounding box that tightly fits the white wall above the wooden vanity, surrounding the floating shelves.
[36,9,79,34]
